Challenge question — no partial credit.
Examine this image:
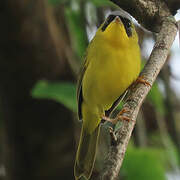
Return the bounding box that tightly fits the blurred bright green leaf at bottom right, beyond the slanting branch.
[121,147,166,180]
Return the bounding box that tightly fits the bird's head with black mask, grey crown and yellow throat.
[96,11,138,46]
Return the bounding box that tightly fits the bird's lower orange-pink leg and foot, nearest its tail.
[102,108,131,124]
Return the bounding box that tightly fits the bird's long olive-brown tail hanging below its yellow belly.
[74,125,100,180]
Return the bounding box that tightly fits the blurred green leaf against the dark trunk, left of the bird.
[32,80,77,112]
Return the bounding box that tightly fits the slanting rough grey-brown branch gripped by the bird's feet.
[100,0,178,180]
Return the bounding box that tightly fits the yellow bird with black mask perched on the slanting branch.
[74,11,141,179]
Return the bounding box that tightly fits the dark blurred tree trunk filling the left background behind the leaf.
[0,0,74,180]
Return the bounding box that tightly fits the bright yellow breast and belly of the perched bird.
[82,42,140,111]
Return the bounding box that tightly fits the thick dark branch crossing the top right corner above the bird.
[110,0,180,32]
